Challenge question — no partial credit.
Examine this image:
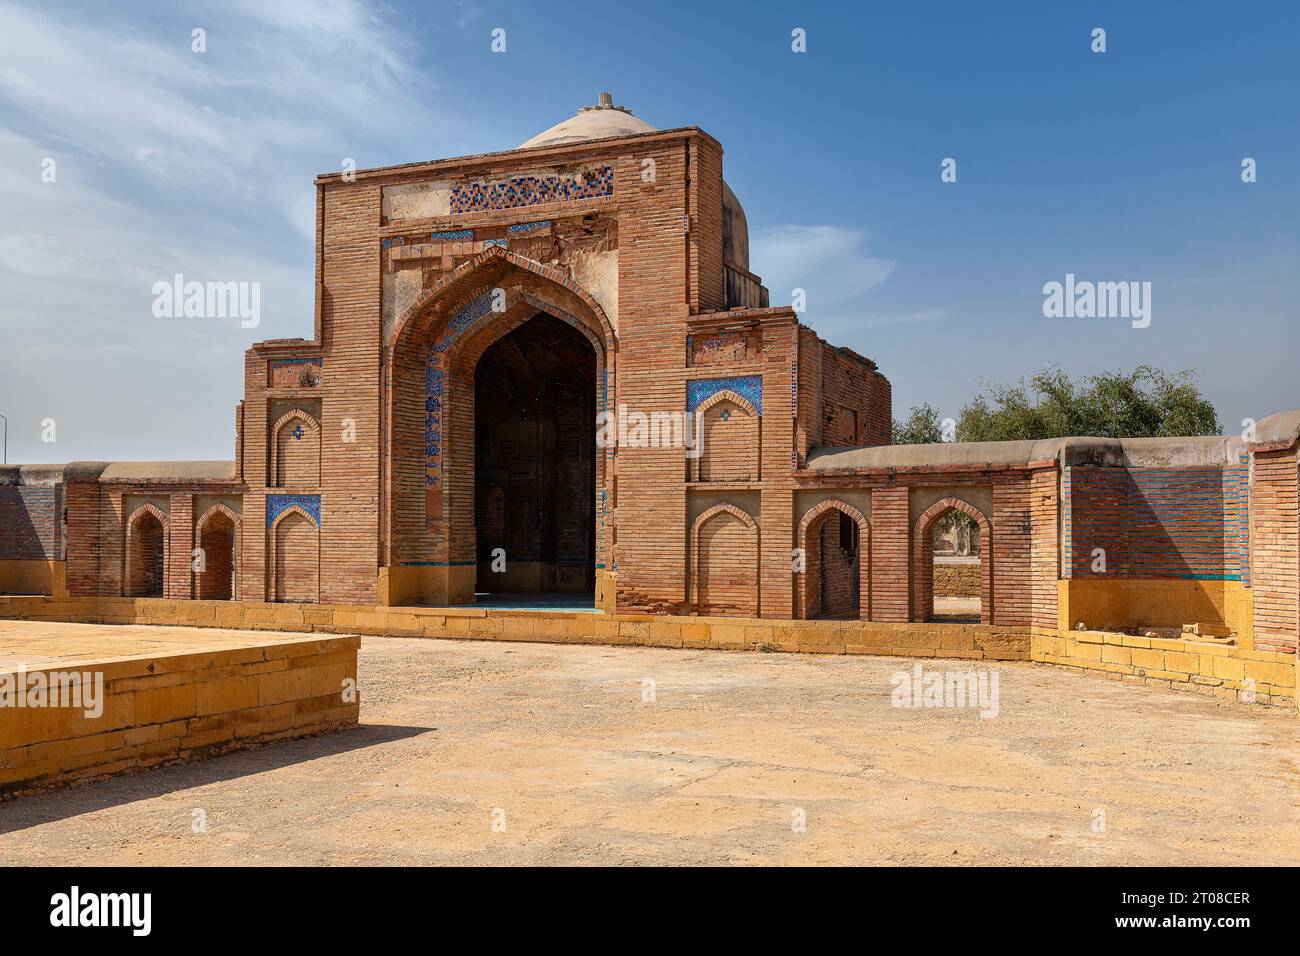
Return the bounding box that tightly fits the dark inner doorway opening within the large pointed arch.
[475,312,597,598]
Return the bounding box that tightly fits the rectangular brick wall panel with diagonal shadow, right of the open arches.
[1061,462,1249,580]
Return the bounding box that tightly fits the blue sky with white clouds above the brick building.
[0,0,1300,462]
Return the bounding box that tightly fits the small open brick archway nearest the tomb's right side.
[796,498,871,620]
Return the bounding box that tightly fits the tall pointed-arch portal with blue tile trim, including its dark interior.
[381,247,616,605]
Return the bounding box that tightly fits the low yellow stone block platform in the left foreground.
[0,620,360,799]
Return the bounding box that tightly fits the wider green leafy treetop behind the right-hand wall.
[957,365,1221,441]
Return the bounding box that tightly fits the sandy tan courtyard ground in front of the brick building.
[0,637,1300,865]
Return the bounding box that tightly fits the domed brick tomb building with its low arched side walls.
[0,96,1300,702]
